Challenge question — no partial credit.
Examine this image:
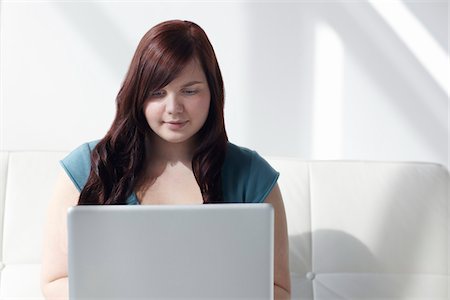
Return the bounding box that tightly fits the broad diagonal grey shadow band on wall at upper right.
[330,3,448,161]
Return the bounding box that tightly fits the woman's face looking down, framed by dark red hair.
[144,59,211,143]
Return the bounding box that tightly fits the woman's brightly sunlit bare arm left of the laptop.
[41,171,80,300]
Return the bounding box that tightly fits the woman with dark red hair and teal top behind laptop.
[42,20,290,299]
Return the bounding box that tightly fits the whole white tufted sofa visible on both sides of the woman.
[0,152,450,300]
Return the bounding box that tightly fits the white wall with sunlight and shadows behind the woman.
[0,1,449,167]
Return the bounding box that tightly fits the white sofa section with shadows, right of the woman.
[271,160,450,300]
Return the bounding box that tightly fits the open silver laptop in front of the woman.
[68,203,274,300]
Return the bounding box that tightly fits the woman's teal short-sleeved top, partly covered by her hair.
[60,141,279,204]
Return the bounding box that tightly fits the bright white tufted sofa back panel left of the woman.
[2,152,65,265]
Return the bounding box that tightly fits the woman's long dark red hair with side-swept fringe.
[78,20,228,205]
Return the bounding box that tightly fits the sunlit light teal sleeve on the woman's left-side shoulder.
[60,142,97,192]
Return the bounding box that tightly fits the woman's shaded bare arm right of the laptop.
[265,184,291,300]
